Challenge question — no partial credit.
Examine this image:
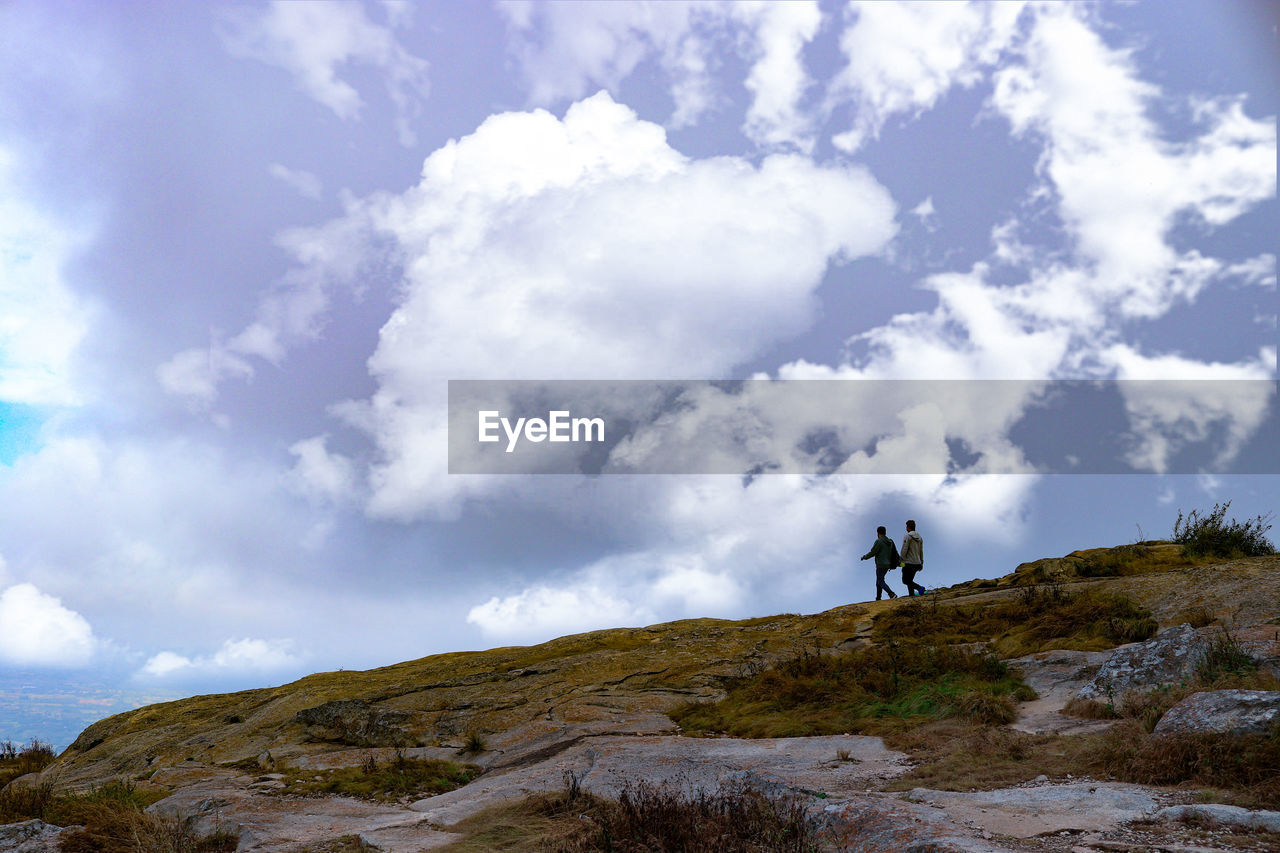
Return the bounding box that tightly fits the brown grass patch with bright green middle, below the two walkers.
[671,642,1036,738]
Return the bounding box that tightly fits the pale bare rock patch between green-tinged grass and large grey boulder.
[1009,649,1111,734]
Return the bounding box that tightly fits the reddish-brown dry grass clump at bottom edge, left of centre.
[443,775,822,853]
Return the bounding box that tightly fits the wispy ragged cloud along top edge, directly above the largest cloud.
[499,0,822,151]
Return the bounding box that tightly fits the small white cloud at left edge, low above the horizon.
[0,584,99,667]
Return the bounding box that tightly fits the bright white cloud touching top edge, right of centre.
[827,0,1025,152]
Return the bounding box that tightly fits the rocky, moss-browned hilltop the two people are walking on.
[0,543,1280,853]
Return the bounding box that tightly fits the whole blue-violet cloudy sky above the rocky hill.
[0,0,1280,739]
